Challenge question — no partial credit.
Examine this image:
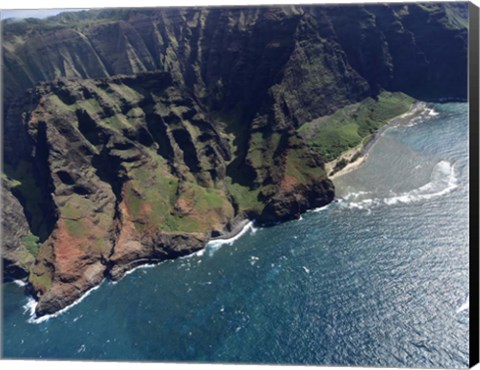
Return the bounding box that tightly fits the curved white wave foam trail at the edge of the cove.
[343,160,458,209]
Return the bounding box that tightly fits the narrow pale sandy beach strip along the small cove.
[325,101,427,180]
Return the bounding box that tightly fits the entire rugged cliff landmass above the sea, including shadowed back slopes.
[2,4,468,315]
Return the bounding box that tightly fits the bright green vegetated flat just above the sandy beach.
[298,92,414,162]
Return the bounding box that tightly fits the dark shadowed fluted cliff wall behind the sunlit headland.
[2,3,468,104]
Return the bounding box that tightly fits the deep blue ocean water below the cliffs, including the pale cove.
[3,103,469,367]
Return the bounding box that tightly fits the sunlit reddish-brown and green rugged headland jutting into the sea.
[6,72,333,315]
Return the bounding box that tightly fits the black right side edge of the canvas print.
[468,2,480,367]
